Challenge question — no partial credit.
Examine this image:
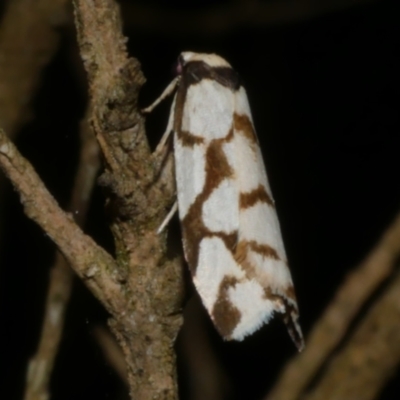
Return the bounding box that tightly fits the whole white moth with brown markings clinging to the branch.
[144,52,304,351]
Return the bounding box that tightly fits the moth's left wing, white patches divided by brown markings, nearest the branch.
[174,79,244,337]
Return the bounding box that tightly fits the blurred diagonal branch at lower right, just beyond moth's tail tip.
[266,214,400,400]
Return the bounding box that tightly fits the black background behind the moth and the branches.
[0,1,400,400]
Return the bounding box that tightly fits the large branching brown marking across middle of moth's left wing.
[181,130,237,275]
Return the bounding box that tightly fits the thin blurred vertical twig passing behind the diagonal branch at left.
[25,118,100,400]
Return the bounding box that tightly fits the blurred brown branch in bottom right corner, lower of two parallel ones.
[304,268,400,400]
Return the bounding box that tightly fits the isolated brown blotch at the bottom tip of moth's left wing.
[211,276,241,339]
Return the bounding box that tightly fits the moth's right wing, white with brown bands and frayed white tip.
[229,87,303,349]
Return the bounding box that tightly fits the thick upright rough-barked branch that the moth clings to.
[74,5,184,400]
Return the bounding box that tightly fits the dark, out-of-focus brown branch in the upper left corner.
[0,0,68,252]
